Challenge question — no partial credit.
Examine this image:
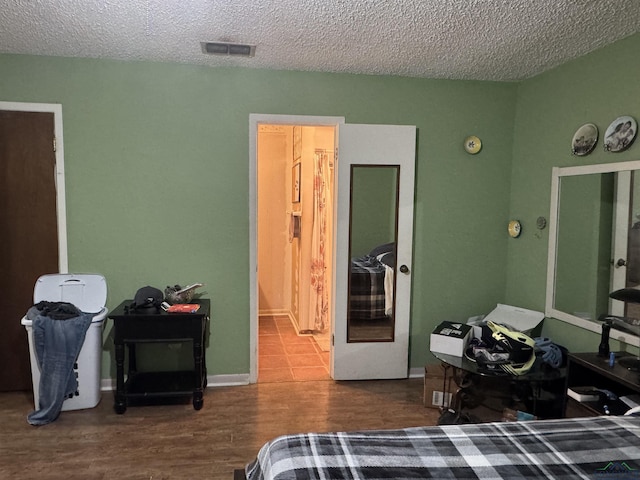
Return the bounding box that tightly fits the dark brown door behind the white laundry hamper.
[0,110,58,391]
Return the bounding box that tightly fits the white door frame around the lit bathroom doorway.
[249,113,345,383]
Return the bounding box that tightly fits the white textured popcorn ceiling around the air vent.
[0,0,640,80]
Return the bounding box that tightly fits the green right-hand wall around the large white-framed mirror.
[505,34,640,351]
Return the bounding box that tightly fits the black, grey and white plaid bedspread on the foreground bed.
[245,416,640,480]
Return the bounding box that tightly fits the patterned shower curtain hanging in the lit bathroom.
[309,151,331,332]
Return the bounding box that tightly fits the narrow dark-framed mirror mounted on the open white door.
[347,165,400,343]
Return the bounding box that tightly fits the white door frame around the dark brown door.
[0,102,69,273]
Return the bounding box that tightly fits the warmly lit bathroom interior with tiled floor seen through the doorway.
[256,123,335,382]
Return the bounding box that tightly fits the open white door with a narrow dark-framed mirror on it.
[331,124,416,380]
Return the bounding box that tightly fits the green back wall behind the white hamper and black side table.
[0,55,516,377]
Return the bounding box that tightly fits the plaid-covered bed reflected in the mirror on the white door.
[349,255,386,320]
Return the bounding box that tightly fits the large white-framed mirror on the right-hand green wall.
[545,161,640,346]
